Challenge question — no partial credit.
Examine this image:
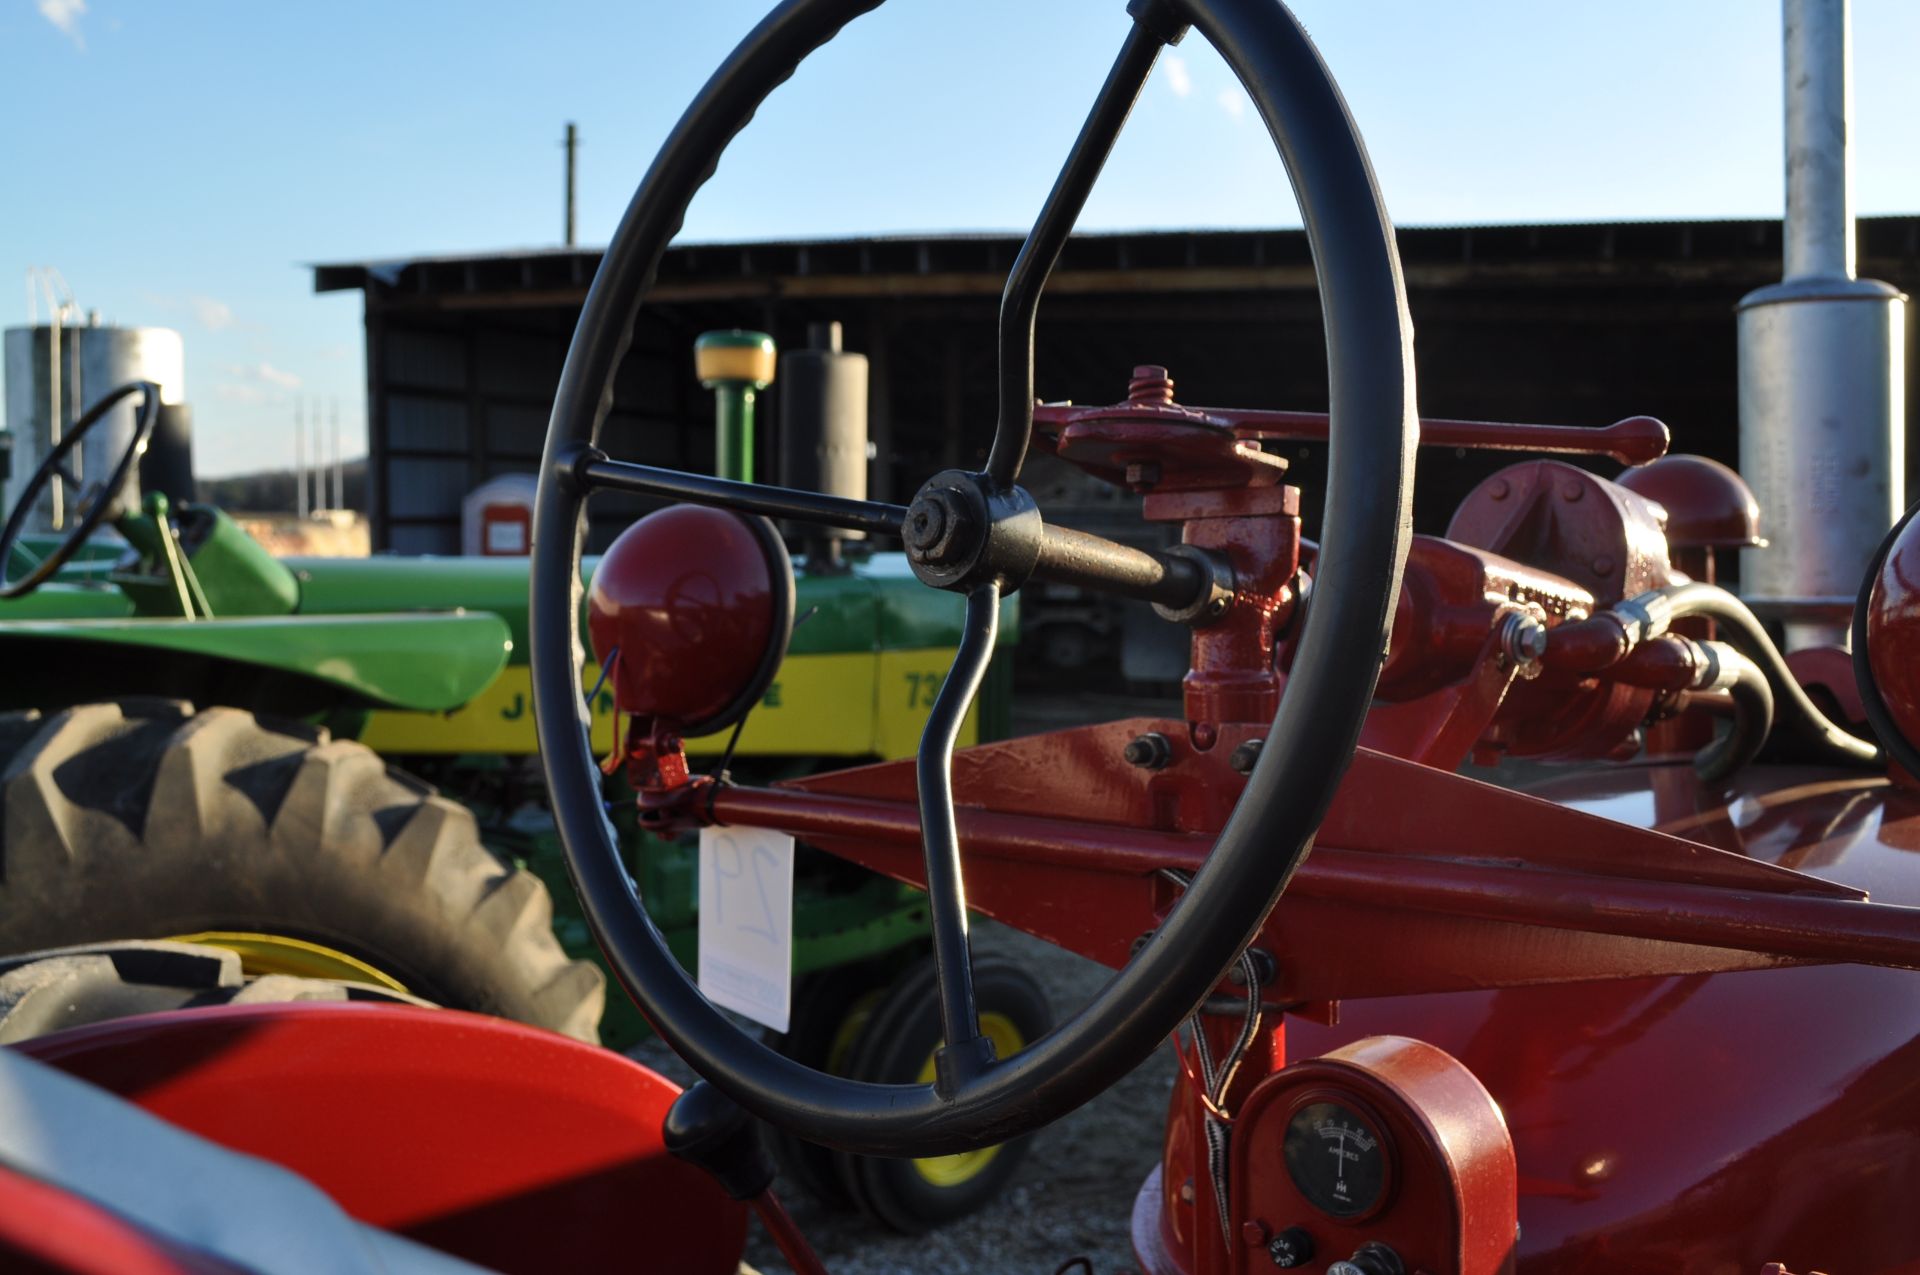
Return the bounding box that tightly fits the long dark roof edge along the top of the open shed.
[313,215,1920,309]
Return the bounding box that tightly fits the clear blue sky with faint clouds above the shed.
[0,0,1920,474]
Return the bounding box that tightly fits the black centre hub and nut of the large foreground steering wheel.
[900,469,1044,591]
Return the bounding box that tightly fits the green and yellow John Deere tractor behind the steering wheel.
[0,334,1050,1229]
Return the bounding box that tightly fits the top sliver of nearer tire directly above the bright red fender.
[0,943,426,1045]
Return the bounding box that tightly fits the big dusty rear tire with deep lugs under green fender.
[0,699,605,1041]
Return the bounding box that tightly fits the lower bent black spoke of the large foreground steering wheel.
[914,580,1000,1093]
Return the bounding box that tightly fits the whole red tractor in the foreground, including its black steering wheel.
[0,0,1920,1275]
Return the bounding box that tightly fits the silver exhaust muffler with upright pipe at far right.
[1738,0,1907,647]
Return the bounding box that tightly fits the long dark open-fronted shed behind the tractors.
[315,217,1920,553]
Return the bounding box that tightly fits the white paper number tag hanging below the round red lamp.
[699,828,793,1031]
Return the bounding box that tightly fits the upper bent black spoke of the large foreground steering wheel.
[987,14,1185,488]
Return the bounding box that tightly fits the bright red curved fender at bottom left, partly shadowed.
[15,1002,747,1275]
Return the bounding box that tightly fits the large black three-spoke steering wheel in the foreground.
[530,0,1417,1156]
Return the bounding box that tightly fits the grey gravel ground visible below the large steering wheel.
[636,922,1173,1275]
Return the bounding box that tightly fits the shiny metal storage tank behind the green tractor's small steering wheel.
[6,325,186,534]
